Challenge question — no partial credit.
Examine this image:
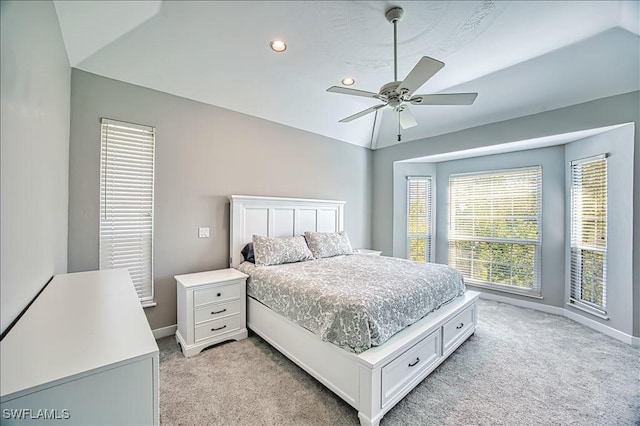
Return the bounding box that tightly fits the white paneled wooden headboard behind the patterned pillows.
[229,195,345,267]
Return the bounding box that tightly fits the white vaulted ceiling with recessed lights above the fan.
[54,0,640,148]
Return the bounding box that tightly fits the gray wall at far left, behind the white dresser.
[0,1,71,331]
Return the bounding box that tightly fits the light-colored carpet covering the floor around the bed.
[158,300,640,426]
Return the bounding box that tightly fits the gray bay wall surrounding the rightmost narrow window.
[565,126,638,334]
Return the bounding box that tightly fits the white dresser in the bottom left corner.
[0,269,160,425]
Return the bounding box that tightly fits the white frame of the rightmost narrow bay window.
[568,153,609,319]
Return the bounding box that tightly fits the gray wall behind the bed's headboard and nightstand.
[69,69,371,329]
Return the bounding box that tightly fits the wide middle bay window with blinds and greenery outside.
[449,167,542,296]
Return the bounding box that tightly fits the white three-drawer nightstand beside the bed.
[174,269,247,357]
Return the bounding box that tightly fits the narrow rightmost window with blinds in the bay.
[570,155,607,314]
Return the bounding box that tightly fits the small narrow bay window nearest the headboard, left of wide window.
[407,177,432,262]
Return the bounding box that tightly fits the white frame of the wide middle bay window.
[447,165,543,299]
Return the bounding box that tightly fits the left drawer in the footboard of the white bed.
[381,328,440,408]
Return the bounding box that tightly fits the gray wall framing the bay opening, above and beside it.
[372,92,640,336]
